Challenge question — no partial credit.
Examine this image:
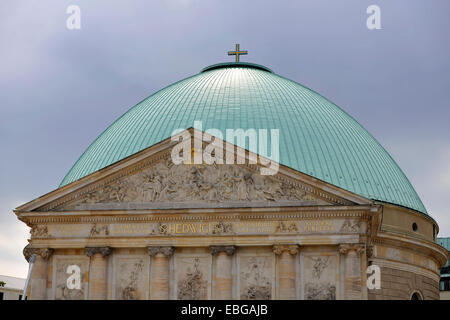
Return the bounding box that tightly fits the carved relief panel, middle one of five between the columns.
[175,254,211,300]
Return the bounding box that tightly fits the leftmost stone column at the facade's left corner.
[23,245,53,300]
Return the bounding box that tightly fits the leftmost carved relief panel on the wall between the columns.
[53,256,89,300]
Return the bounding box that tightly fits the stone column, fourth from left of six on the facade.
[210,246,236,300]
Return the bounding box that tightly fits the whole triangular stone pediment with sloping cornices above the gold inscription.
[17,129,370,212]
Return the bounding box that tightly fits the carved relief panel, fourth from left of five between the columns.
[239,255,274,300]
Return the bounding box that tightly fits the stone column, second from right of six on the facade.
[273,245,299,300]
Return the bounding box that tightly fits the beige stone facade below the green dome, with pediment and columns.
[16,136,448,300]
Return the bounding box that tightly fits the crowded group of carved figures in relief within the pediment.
[74,159,314,205]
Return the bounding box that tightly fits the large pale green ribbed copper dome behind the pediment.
[60,63,426,213]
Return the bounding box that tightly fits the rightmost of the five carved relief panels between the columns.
[303,254,337,300]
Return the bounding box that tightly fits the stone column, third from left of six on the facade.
[147,247,175,300]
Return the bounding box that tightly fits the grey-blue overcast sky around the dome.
[0,0,450,277]
